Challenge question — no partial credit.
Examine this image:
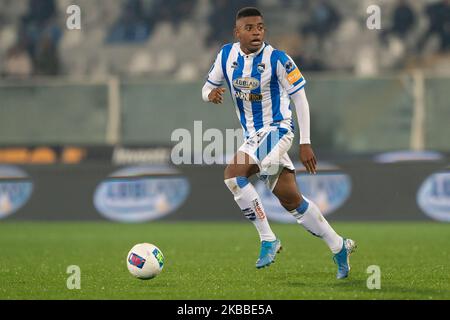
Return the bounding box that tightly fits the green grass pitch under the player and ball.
[0,221,450,300]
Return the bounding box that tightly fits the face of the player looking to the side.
[235,17,265,53]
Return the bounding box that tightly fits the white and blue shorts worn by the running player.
[238,127,295,190]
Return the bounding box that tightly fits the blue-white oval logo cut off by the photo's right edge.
[417,171,450,222]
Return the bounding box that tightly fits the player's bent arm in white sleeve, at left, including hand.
[202,50,225,104]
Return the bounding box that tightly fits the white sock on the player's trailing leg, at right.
[290,198,344,254]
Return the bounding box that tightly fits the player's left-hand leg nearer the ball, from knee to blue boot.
[224,152,281,269]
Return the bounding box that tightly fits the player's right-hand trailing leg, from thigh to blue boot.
[273,168,356,279]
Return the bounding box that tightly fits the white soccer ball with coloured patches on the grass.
[127,243,164,280]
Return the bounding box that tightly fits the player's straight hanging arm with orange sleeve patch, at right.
[278,52,317,174]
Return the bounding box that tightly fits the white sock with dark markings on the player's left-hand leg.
[225,177,277,241]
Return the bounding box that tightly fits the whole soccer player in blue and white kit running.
[202,7,356,279]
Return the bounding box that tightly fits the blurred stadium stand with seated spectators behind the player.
[0,0,450,80]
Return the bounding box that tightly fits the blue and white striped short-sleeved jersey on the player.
[207,43,306,138]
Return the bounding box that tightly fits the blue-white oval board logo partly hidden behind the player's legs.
[256,163,351,223]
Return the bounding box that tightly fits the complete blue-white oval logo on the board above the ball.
[94,165,189,222]
